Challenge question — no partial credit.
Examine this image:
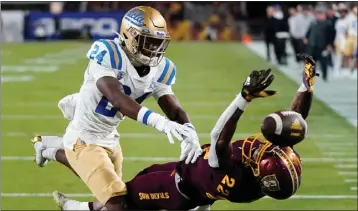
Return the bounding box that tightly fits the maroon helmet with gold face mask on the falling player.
[242,134,302,199]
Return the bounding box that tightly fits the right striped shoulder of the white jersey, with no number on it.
[157,57,176,86]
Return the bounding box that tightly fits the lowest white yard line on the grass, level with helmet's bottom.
[1,193,357,199]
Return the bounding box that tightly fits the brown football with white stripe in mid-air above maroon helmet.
[261,111,307,146]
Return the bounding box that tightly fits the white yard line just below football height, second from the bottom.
[1,156,357,162]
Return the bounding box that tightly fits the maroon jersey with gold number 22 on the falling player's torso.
[176,140,264,206]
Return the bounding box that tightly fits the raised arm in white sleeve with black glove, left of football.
[209,69,276,168]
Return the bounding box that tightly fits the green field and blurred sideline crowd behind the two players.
[0,1,358,210]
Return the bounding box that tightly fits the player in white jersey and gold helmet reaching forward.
[34,6,202,210]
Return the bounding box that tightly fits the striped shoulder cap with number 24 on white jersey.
[87,39,124,70]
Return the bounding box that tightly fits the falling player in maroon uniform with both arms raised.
[49,55,316,210]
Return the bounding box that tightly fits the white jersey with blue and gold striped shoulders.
[64,39,176,149]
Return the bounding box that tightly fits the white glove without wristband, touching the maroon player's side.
[179,123,203,164]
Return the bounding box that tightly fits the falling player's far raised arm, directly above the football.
[291,54,318,119]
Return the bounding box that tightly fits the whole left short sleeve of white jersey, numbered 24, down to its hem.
[87,40,124,81]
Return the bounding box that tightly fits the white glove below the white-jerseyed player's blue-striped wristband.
[154,118,191,144]
